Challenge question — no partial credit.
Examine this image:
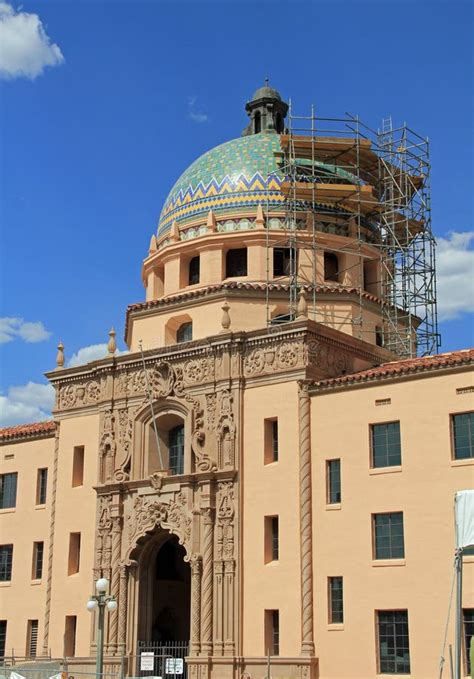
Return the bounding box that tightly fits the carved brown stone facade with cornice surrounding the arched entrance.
[43,322,378,677]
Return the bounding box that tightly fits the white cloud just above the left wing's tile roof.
[0,382,54,427]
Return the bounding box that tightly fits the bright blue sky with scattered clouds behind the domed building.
[0,0,474,423]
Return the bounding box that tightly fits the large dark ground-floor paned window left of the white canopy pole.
[377,611,410,674]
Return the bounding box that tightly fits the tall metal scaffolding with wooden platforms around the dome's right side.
[266,102,439,357]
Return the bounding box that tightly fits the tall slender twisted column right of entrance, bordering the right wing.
[298,382,314,655]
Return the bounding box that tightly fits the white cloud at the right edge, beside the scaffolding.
[436,231,474,321]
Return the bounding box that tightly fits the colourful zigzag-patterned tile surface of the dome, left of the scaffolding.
[158,133,284,237]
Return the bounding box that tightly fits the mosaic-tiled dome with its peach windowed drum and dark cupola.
[134,85,403,351]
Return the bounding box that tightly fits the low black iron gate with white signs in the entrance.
[136,641,189,679]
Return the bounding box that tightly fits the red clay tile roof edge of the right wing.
[312,349,474,389]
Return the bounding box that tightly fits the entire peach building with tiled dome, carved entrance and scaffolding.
[0,83,474,679]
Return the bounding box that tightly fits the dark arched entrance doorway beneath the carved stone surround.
[137,530,191,676]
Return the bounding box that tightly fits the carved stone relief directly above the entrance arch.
[127,492,192,558]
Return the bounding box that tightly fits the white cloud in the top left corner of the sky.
[0,1,64,80]
